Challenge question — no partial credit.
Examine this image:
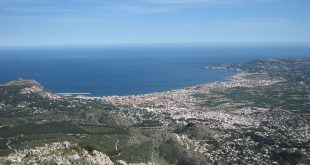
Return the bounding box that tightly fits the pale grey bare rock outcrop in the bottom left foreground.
[0,141,114,165]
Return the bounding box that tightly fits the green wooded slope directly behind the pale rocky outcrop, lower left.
[0,121,160,163]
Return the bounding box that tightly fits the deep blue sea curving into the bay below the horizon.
[0,45,310,96]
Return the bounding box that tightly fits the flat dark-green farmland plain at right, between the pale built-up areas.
[225,82,310,115]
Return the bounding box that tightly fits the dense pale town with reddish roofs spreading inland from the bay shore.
[97,72,282,128]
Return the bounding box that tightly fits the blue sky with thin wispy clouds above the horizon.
[0,0,310,46]
